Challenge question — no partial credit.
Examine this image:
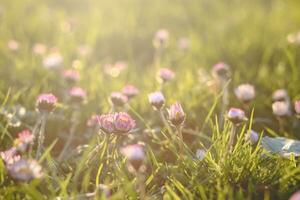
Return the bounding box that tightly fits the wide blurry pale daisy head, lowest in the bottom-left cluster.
[7,158,43,182]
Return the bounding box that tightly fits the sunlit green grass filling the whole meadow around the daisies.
[0,0,300,200]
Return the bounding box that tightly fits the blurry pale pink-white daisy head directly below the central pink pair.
[121,144,145,171]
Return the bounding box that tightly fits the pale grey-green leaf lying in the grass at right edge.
[262,136,300,157]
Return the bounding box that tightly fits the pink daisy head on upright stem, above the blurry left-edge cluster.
[36,93,57,112]
